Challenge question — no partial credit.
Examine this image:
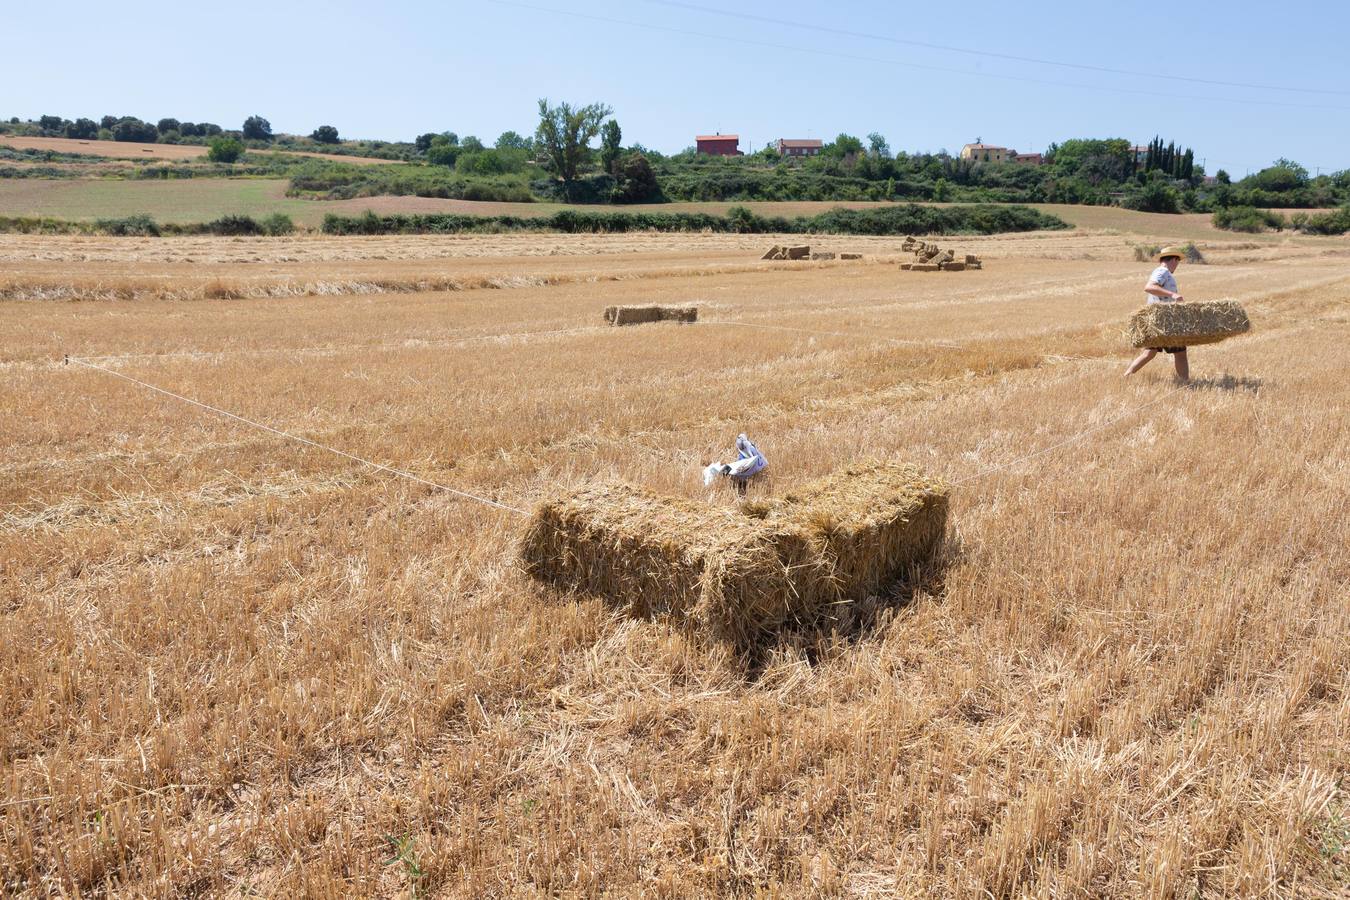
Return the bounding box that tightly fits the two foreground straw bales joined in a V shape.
[520,463,948,649]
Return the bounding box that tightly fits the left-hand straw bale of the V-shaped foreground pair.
[520,483,828,645]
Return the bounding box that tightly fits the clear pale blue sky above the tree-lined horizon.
[0,0,1350,177]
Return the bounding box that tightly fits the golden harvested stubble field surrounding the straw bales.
[0,223,1350,897]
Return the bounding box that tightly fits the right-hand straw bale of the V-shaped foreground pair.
[765,461,949,602]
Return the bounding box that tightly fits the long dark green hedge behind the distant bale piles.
[323,204,1069,235]
